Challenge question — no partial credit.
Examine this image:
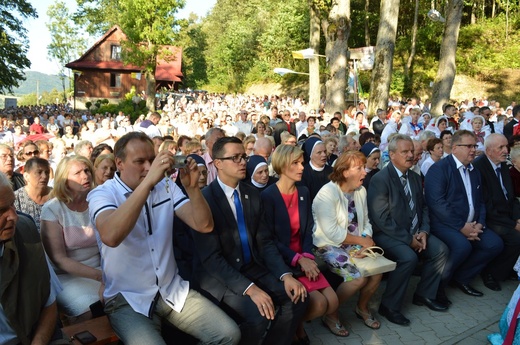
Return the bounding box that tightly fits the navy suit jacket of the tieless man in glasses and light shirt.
[424,154,486,232]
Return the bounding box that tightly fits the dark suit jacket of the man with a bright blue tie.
[192,180,291,301]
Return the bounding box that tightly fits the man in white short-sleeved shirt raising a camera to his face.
[87,132,240,345]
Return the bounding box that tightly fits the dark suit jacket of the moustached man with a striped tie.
[367,162,430,245]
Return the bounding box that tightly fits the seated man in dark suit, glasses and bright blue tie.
[193,137,307,344]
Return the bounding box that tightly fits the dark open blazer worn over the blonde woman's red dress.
[261,184,314,266]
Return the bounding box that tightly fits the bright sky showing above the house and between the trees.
[24,0,216,74]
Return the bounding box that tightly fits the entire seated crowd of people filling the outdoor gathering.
[0,94,520,344]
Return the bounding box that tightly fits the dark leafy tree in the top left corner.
[0,0,38,93]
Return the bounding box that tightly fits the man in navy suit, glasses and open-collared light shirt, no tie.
[424,130,504,303]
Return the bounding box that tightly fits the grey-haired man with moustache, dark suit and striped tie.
[367,134,448,325]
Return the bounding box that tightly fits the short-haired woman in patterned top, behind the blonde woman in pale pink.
[14,157,52,231]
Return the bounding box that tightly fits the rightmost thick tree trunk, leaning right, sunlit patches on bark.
[431,0,464,115]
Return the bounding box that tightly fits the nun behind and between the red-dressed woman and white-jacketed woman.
[299,137,332,200]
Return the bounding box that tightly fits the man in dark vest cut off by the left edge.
[0,173,58,344]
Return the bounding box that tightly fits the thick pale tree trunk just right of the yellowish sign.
[368,0,399,115]
